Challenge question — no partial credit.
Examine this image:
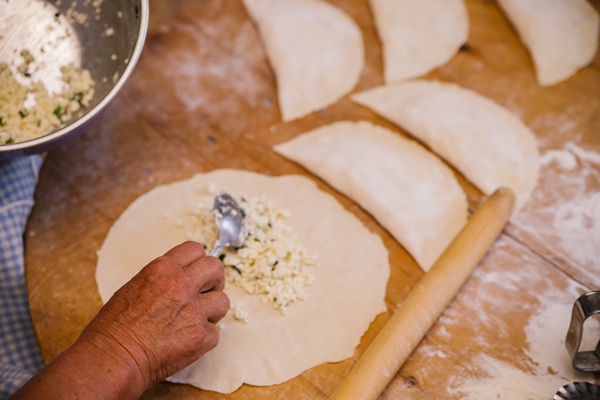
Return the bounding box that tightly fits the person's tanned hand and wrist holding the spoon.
[14,242,229,399]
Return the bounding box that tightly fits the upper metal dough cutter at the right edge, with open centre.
[565,290,600,372]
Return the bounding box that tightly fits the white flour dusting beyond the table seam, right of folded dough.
[509,142,600,287]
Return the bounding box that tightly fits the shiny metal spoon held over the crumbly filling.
[209,192,248,257]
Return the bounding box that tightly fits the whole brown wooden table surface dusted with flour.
[25,0,600,399]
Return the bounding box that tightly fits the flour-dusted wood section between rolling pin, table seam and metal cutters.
[383,235,600,400]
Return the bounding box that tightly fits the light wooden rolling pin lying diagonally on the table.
[330,188,515,400]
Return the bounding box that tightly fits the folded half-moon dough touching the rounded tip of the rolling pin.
[352,80,540,215]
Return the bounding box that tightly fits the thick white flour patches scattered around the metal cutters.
[446,246,600,400]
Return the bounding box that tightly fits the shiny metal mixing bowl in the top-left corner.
[0,0,149,158]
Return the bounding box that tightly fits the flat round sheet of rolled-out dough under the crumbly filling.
[96,170,390,393]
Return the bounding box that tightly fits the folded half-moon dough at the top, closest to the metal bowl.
[243,0,364,121]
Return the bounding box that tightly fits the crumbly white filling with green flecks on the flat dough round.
[177,188,318,323]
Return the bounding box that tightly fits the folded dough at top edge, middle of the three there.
[369,0,469,83]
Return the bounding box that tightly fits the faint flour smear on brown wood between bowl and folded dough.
[128,23,276,132]
